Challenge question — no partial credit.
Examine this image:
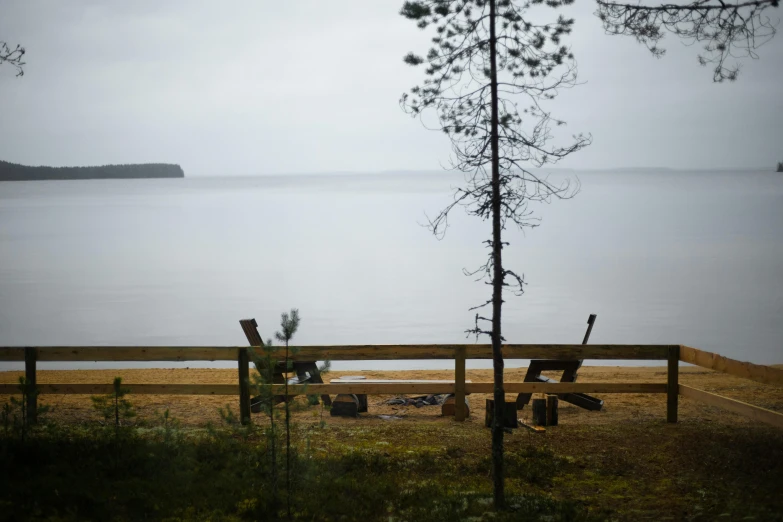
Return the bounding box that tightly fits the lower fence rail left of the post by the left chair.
[0,382,239,395]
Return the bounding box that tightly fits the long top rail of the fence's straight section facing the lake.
[0,344,669,361]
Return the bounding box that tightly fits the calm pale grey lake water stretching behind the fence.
[0,172,783,369]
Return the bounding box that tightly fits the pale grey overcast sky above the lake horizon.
[0,0,783,176]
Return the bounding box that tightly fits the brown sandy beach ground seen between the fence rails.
[0,366,783,427]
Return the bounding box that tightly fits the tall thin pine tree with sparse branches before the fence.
[401,0,590,509]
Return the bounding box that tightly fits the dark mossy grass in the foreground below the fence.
[0,410,783,522]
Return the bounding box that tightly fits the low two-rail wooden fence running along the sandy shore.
[0,344,783,428]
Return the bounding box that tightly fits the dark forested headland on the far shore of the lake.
[0,161,185,181]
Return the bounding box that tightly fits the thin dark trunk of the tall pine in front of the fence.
[489,0,506,510]
